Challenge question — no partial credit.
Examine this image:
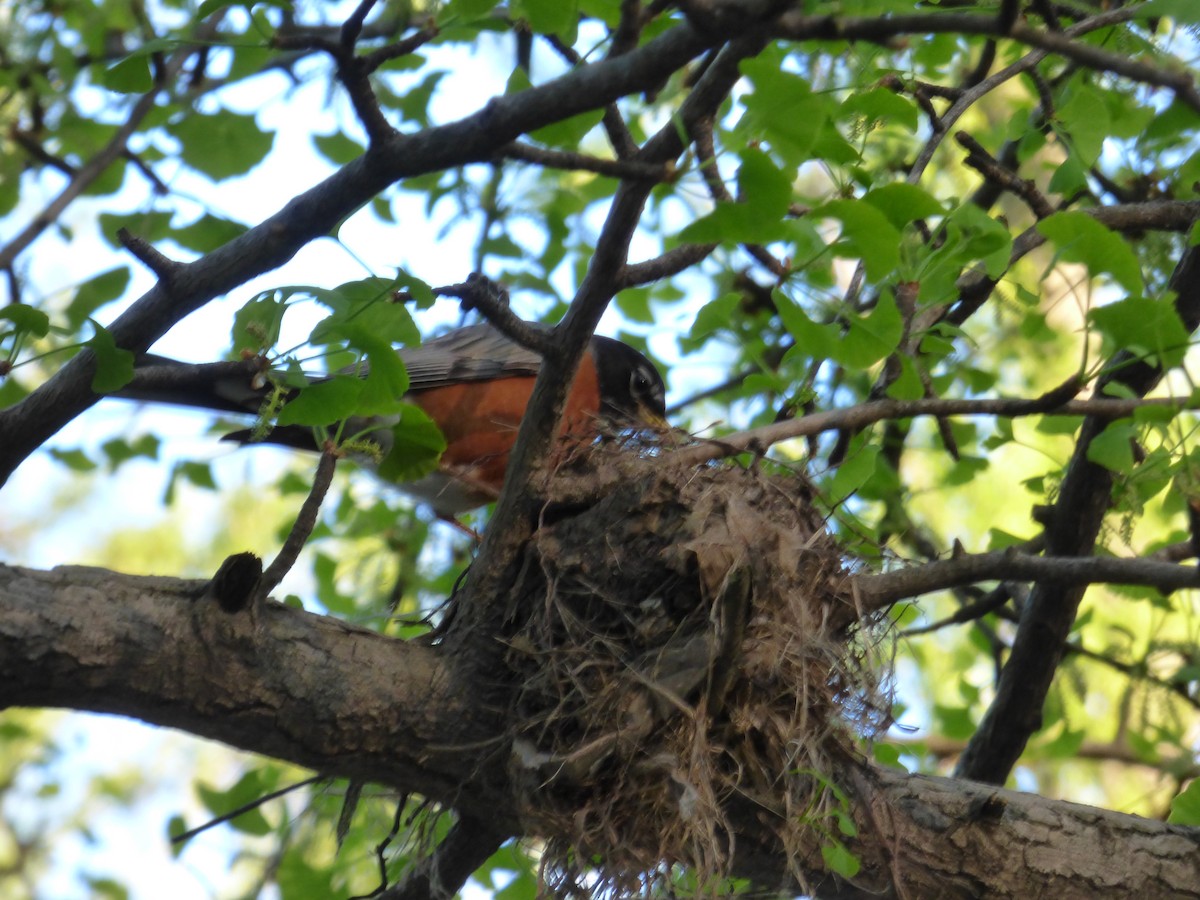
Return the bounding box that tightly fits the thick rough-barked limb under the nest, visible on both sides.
[0,566,1200,898]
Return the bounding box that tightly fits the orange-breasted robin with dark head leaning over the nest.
[116,324,667,518]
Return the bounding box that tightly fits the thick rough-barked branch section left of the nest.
[0,565,515,827]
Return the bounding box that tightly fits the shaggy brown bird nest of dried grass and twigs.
[508,448,888,895]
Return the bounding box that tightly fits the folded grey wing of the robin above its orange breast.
[397,324,541,391]
